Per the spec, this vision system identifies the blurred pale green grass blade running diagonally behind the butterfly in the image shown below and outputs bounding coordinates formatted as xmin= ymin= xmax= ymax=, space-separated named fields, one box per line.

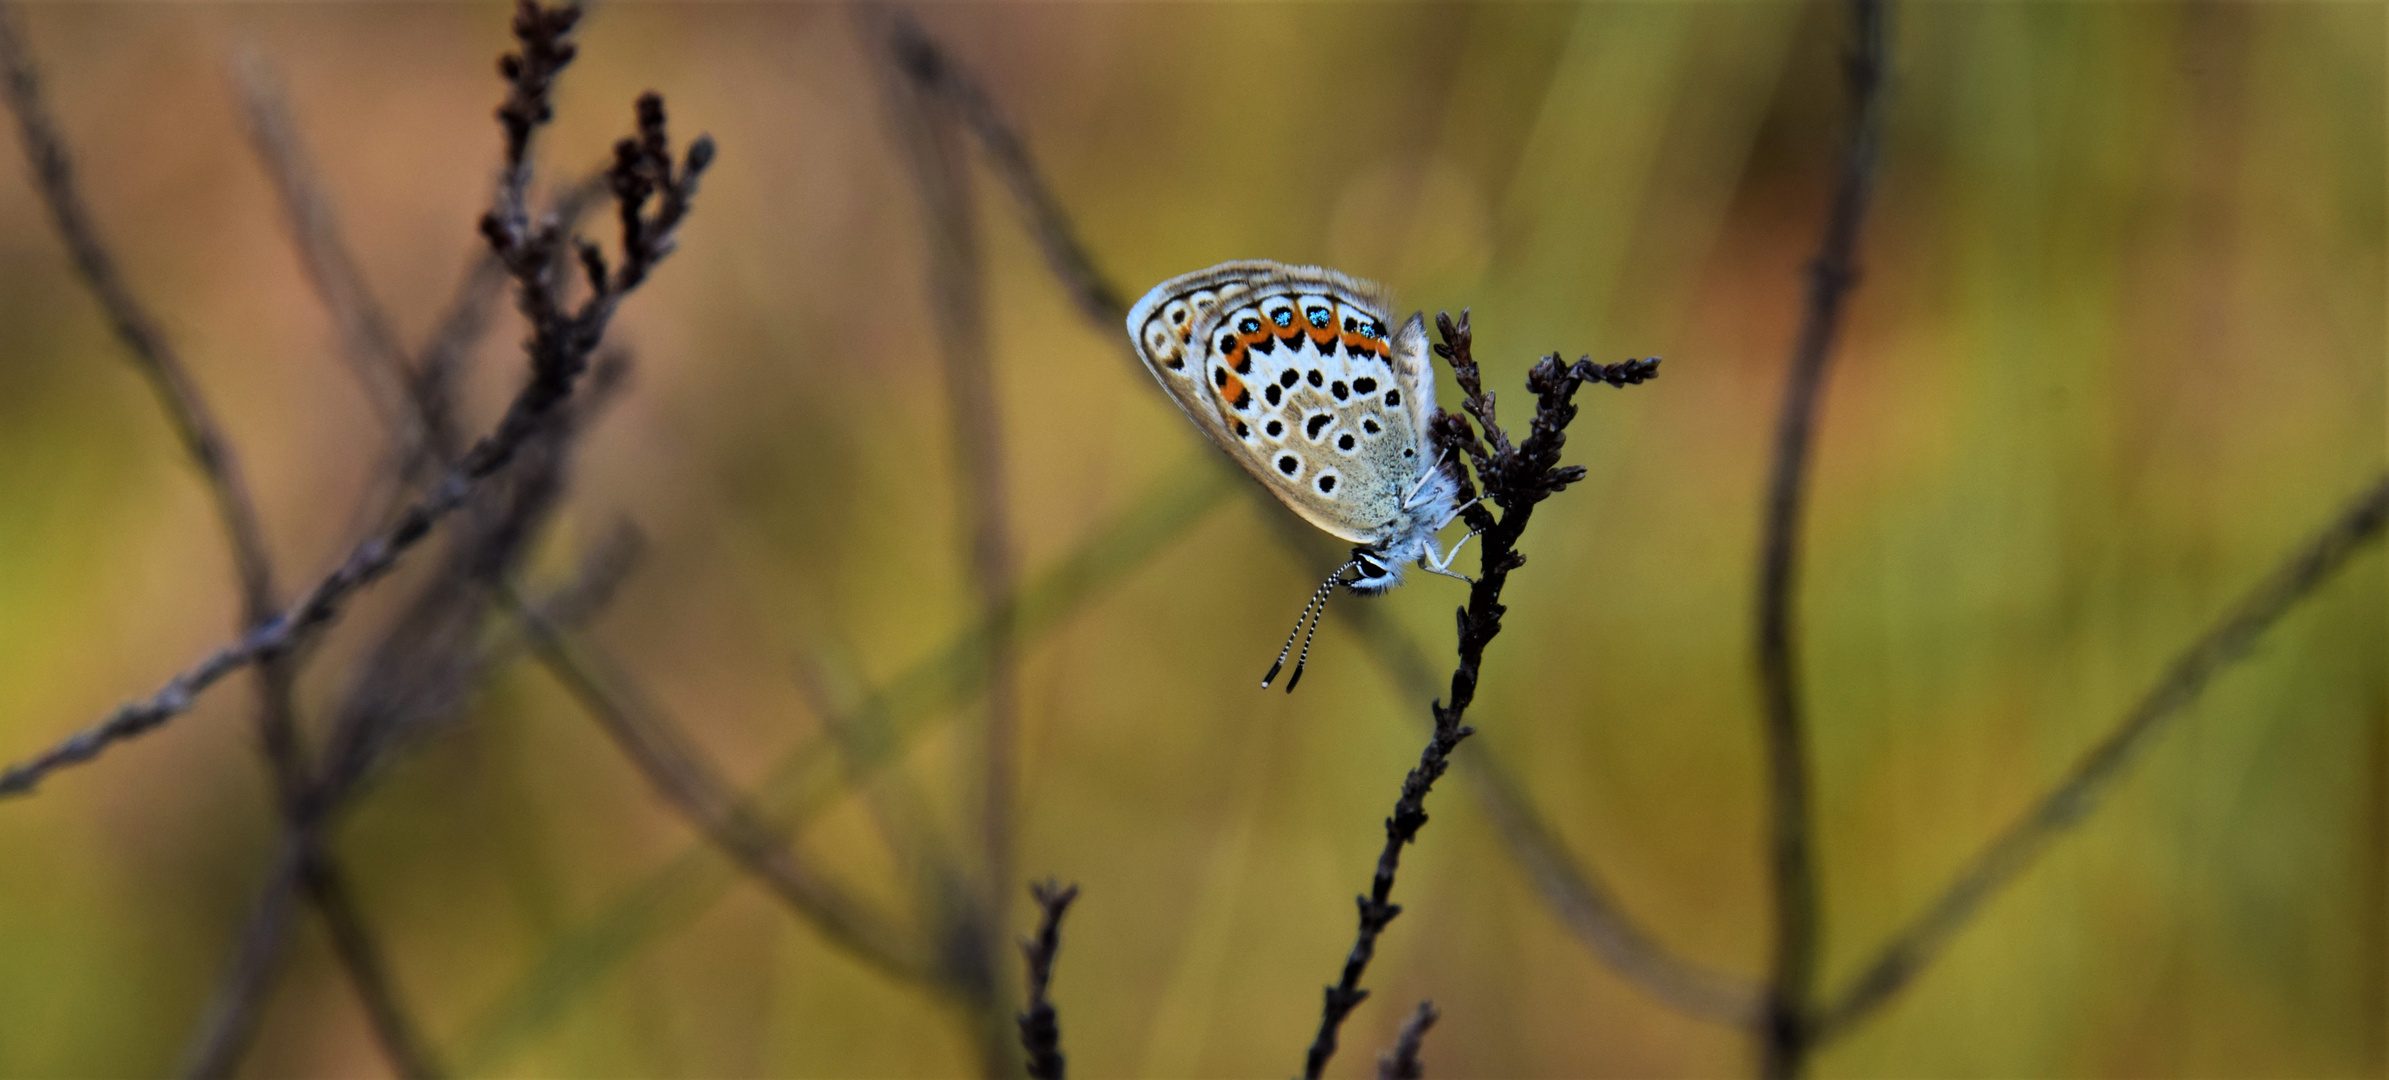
xmin=447 ymin=449 xmax=1238 ymax=1075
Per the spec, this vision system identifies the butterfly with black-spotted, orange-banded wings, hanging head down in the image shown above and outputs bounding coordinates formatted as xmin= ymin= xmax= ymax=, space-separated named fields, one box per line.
xmin=1128 ymin=260 xmax=1474 ymax=693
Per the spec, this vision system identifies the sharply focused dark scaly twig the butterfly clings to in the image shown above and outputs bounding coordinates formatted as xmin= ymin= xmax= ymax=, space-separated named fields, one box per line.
xmin=1302 ymin=311 xmax=1658 ymax=1080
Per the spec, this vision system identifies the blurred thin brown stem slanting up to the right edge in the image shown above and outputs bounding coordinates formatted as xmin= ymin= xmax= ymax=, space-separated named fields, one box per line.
xmin=1813 ymin=473 xmax=2389 ymax=1042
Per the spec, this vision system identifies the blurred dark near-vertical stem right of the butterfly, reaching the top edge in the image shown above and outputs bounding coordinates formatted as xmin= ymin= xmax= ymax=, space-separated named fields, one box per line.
xmin=1751 ymin=0 xmax=1885 ymax=1078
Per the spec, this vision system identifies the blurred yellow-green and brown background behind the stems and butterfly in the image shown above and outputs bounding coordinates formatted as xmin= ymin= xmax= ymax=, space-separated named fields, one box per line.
xmin=0 ymin=2 xmax=2389 ymax=1078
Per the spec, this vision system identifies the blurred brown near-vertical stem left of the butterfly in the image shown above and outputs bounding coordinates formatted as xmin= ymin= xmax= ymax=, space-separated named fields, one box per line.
xmin=858 ymin=7 xmax=1020 ymax=1060
